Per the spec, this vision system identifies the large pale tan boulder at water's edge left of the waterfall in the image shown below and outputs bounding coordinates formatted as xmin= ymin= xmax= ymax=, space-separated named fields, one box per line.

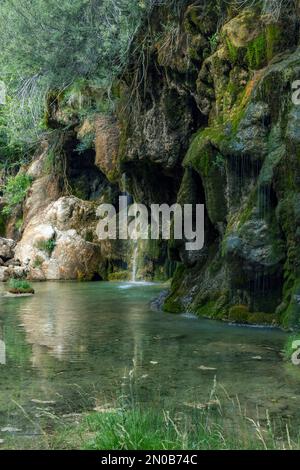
xmin=16 ymin=197 xmax=105 ymax=280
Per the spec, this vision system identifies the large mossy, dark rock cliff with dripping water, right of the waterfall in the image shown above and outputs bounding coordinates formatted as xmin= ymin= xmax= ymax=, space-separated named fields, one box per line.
xmin=116 ymin=1 xmax=300 ymax=326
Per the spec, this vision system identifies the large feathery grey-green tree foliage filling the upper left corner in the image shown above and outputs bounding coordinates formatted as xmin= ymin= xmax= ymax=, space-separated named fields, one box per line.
xmin=0 ymin=0 xmax=156 ymax=152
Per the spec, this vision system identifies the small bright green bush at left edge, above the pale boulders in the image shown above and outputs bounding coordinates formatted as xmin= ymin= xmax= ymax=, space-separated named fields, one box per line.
xmin=2 ymin=174 xmax=32 ymax=215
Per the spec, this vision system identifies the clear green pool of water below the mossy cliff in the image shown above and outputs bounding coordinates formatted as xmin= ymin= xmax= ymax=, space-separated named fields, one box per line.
xmin=0 ymin=282 xmax=300 ymax=446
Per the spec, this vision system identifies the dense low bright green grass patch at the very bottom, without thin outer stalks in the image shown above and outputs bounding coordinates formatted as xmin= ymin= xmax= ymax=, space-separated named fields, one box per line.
xmin=45 ymin=408 xmax=299 ymax=450
